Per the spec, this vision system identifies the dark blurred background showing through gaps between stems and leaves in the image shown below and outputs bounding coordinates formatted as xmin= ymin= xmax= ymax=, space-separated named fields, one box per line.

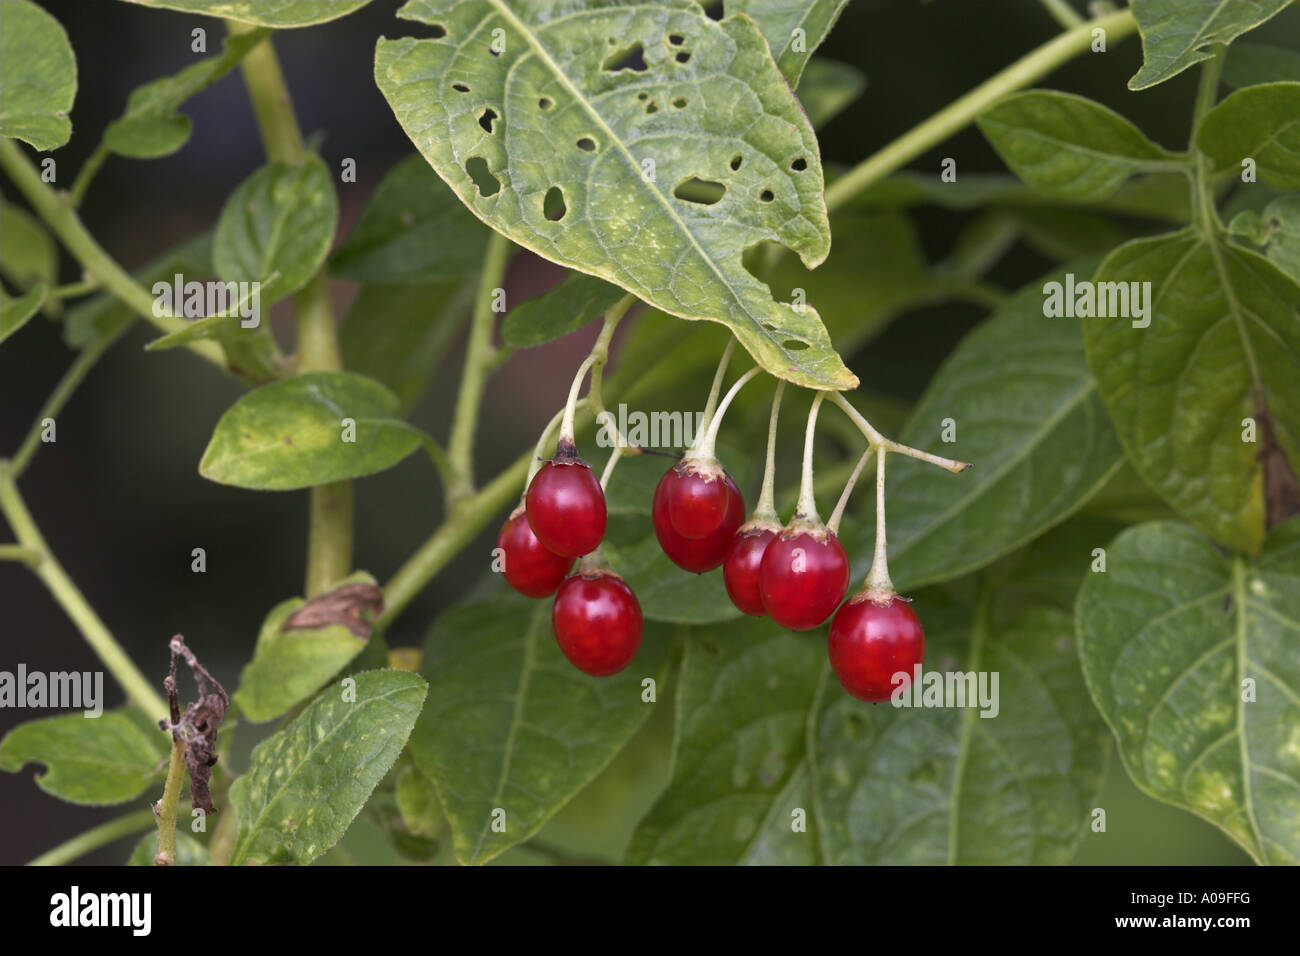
xmin=0 ymin=0 xmax=1300 ymax=864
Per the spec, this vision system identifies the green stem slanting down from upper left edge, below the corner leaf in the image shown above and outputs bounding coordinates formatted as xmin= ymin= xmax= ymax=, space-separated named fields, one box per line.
xmin=0 ymin=138 xmax=229 ymax=372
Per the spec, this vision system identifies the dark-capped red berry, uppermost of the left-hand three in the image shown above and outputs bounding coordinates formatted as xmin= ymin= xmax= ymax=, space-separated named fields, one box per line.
xmin=527 ymin=454 xmax=606 ymax=558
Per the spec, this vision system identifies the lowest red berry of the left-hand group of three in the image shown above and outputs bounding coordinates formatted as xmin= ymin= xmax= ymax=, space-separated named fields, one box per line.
xmin=551 ymin=571 xmax=641 ymax=678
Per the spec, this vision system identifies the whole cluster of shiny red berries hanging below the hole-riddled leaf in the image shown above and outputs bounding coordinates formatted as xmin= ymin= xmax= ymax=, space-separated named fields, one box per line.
xmin=497 ymin=442 xmax=926 ymax=701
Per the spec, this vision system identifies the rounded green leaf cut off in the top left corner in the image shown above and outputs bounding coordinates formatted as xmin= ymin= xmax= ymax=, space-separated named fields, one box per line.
xmin=0 ymin=0 xmax=77 ymax=152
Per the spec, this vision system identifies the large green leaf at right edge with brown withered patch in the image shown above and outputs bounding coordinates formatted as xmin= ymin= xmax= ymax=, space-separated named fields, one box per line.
xmin=1084 ymin=229 xmax=1300 ymax=553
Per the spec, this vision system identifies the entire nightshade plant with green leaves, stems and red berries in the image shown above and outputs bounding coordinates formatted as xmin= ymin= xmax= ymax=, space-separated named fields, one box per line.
xmin=0 ymin=0 xmax=1300 ymax=865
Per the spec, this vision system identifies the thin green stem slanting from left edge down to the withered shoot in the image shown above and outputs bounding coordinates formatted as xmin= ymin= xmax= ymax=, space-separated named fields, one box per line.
xmin=0 ymin=460 xmax=168 ymax=721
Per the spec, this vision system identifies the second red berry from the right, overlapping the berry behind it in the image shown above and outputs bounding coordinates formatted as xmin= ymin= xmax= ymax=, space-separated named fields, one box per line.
xmin=758 ymin=522 xmax=849 ymax=631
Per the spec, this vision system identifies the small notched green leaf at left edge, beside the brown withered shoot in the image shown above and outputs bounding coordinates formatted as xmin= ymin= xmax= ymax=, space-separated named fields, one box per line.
xmin=0 ymin=709 xmax=169 ymax=806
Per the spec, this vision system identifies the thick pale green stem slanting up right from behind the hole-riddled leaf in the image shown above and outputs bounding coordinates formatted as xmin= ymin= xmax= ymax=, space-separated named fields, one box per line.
xmin=826 ymin=10 xmax=1138 ymax=209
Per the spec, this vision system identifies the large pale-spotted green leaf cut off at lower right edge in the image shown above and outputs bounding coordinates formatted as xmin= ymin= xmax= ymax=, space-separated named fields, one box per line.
xmin=1076 ymin=520 xmax=1300 ymax=864
